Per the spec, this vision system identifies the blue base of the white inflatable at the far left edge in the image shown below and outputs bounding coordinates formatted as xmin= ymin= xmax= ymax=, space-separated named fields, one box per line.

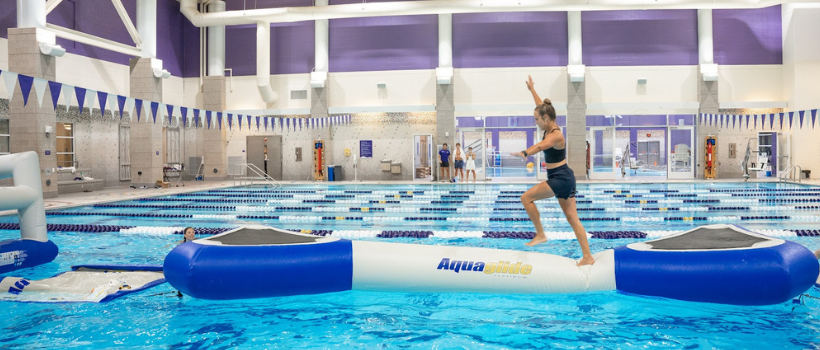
xmin=0 ymin=239 xmax=59 ymax=273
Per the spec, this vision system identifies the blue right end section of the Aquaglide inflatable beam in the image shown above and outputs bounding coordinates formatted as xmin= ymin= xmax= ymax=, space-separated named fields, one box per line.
xmin=615 ymin=241 xmax=820 ymax=305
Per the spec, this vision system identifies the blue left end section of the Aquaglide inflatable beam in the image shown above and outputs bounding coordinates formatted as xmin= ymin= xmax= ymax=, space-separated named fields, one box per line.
xmin=163 ymin=240 xmax=353 ymax=300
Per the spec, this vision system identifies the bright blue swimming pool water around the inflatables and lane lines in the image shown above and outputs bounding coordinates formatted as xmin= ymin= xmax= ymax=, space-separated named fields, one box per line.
xmin=0 ymin=183 xmax=820 ymax=349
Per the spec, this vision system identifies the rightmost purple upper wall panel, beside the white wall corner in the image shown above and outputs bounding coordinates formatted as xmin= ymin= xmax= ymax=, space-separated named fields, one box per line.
xmin=712 ymin=6 xmax=783 ymax=64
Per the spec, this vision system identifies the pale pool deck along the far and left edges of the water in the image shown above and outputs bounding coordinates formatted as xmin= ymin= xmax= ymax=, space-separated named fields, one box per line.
xmin=0 ymin=177 xmax=820 ymax=216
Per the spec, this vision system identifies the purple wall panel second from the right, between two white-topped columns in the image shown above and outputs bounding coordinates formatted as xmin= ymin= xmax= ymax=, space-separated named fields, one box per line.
xmin=581 ymin=10 xmax=698 ymax=66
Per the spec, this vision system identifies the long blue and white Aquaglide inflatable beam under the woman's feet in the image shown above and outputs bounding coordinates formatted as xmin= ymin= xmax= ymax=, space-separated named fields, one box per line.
xmin=163 ymin=225 xmax=820 ymax=305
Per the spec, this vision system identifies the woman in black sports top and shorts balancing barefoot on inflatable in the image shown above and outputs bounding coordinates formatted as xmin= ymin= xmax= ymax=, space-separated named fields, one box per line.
xmin=512 ymin=76 xmax=595 ymax=266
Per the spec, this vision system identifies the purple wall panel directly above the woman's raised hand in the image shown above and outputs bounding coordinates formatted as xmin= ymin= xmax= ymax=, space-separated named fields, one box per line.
xmin=453 ymin=12 xmax=568 ymax=68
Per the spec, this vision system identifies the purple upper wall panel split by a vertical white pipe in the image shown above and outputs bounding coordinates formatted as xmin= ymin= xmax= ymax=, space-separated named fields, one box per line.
xmin=225 ymin=21 xmax=315 ymax=75
